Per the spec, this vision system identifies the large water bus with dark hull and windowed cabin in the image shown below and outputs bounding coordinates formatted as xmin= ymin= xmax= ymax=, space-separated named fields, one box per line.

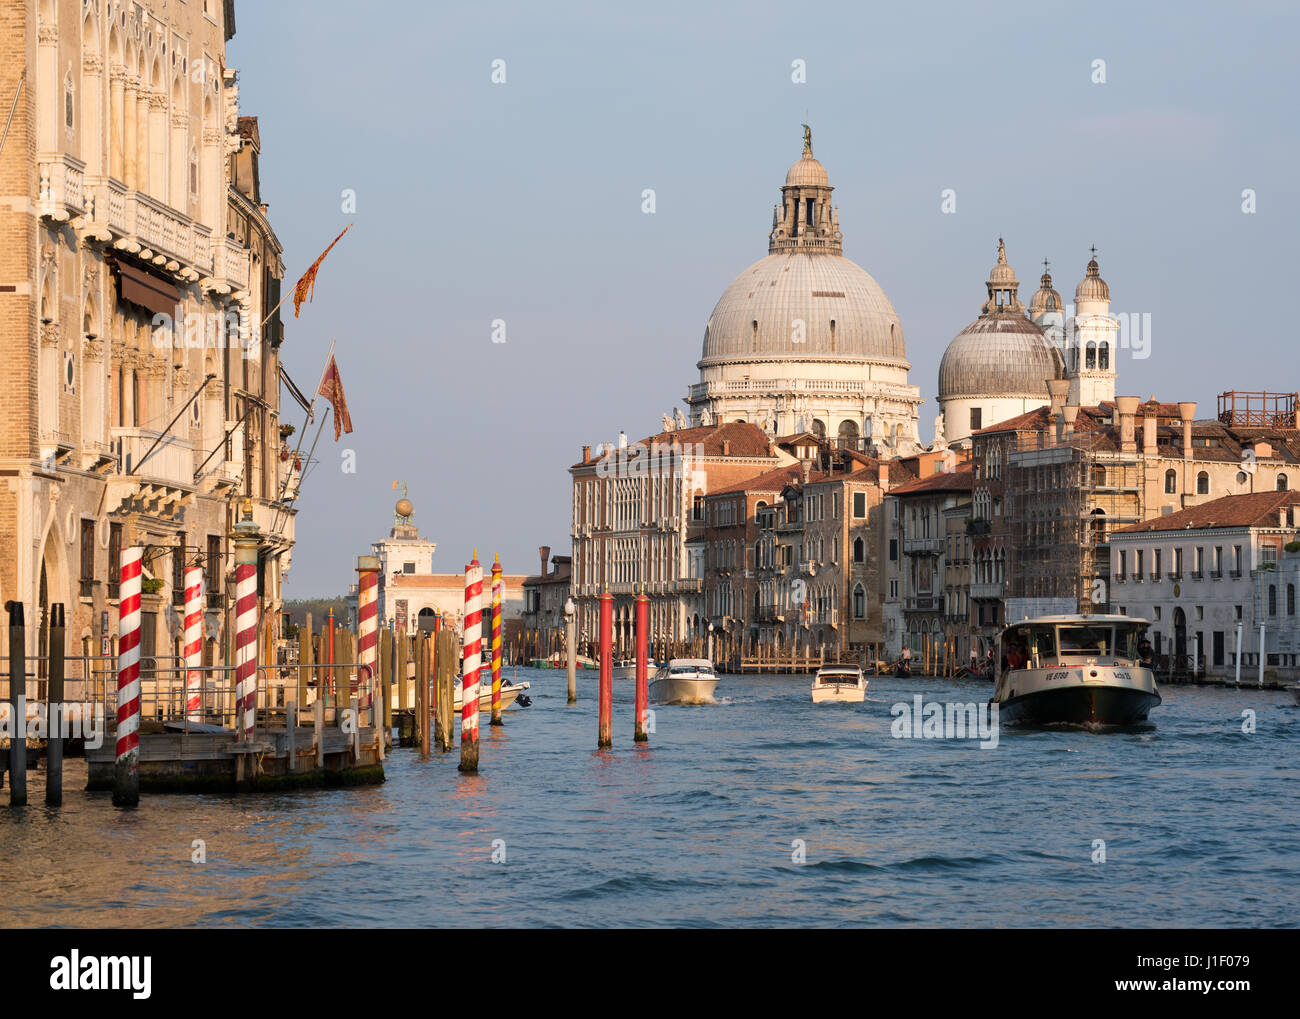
xmin=993 ymin=616 xmax=1161 ymax=725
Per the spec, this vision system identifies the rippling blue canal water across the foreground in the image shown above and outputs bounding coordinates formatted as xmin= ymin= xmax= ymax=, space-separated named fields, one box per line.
xmin=0 ymin=669 xmax=1300 ymax=927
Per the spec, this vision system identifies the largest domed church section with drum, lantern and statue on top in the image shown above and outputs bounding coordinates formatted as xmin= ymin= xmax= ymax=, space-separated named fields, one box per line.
xmin=686 ymin=129 xmax=920 ymax=456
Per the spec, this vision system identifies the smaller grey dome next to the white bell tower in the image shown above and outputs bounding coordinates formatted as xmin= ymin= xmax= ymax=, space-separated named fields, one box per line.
xmin=939 ymin=315 xmax=1065 ymax=402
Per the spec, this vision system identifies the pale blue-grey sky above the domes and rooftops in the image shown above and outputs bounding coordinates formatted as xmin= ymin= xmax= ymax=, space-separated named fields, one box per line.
xmin=228 ymin=0 xmax=1300 ymax=598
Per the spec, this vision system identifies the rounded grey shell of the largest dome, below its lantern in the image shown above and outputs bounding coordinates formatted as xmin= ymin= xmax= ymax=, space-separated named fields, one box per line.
xmin=699 ymin=248 xmax=907 ymax=368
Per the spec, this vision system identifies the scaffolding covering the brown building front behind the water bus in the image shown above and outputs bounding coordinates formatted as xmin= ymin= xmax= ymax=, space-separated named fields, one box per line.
xmin=1004 ymin=432 xmax=1144 ymax=615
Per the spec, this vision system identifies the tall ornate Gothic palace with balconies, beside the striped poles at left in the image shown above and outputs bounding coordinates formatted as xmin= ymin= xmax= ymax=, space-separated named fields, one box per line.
xmin=0 ymin=0 xmax=298 ymax=668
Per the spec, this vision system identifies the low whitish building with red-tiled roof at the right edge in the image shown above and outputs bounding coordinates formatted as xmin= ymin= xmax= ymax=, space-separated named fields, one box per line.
xmin=1109 ymin=490 xmax=1300 ymax=682
